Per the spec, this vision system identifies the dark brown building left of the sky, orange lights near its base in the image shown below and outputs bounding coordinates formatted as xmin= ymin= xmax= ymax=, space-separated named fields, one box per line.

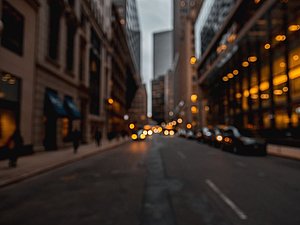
xmin=106 ymin=4 xmax=141 ymax=139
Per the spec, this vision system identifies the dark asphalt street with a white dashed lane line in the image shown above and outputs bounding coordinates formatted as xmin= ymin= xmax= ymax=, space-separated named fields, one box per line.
xmin=0 ymin=136 xmax=300 ymax=225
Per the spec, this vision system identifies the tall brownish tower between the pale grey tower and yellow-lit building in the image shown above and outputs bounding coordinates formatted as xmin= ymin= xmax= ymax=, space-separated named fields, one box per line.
xmin=173 ymin=0 xmax=202 ymax=125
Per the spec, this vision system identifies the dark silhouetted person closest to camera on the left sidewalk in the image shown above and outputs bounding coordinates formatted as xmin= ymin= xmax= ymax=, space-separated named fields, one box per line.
xmin=6 ymin=128 xmax=23 ymax=167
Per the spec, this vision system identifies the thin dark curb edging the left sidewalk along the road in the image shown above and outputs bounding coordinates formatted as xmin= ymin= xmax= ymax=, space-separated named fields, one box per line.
xmin=0 ymin=140 xmax=129 ymax=188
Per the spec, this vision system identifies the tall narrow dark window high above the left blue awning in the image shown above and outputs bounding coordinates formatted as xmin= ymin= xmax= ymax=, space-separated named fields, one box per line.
xmin=48 ymin=1 xmax=61 ymax=60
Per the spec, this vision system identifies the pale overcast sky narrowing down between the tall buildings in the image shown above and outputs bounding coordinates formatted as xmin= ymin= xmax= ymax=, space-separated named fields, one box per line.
xmin=136 ymin=0 xmax=173 ymax=112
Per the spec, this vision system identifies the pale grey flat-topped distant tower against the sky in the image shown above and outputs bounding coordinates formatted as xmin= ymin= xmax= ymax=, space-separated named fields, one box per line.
xmin=153 ymin=31 xmax=173 ymax=79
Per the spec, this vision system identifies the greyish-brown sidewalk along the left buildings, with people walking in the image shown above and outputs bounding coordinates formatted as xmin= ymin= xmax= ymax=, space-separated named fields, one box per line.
xmin=0 ymin=138 xmax=129 ymax=188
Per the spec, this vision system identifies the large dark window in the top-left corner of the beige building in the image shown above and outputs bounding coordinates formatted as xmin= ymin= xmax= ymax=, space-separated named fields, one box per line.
xmin=1 ymin=1 xmax=24 ymax=55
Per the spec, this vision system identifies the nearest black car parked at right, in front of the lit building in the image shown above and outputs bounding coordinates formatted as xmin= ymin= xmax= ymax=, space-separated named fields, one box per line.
xmin=221 ymin=126 xmax=267 ymax=155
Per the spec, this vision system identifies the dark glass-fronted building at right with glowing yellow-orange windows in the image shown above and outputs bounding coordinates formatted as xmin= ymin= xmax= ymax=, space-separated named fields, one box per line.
xmin=197 ymin=0 xmax=300 ymax=139
